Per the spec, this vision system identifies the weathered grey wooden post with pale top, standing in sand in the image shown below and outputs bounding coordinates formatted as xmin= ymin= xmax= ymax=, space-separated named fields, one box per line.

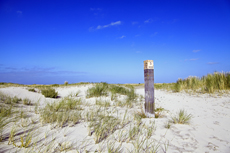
xmin=144 ymin=60 xmax=155 ymax=117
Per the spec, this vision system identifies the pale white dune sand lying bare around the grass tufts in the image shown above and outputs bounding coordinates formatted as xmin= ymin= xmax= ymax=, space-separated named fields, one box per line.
xmin=0 ymin=85 xmax=230 ymax=153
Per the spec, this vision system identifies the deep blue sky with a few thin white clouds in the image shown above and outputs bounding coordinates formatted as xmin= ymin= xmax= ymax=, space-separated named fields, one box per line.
xmin=0 ymin=0 xmax=230 ymax=84
